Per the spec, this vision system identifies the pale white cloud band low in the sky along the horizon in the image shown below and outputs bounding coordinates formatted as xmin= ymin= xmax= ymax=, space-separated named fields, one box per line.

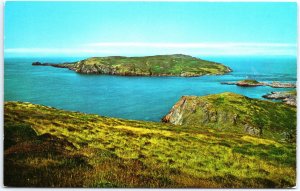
xmin=4 ymin=42 xmax=297 ymax=55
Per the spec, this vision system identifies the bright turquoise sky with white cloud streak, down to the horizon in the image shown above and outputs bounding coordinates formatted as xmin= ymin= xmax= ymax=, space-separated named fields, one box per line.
xmin=4 ymin=1 xmax=297 ymax=57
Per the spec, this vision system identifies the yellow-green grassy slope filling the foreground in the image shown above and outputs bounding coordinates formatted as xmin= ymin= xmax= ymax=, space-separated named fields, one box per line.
xmin=4 ymin=102 xmax=296 ymax=188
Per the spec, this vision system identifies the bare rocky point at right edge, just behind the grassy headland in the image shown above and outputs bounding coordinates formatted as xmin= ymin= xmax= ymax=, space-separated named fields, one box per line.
xmin=262 ymin=90 xmax=297 ymax=106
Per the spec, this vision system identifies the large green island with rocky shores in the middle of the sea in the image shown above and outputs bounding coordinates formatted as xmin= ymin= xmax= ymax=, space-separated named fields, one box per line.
xmin=32 ymin=54 xmax=232 ymax=77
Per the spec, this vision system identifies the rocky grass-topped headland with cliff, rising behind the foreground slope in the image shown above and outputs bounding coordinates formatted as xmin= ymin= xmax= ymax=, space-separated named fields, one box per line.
xmin=162 ymin=93 xmax=296 ymax=141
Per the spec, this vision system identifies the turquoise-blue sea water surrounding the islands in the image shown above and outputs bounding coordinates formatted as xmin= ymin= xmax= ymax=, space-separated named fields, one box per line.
xmin=4 ymin=57 xmax=297 ymax=121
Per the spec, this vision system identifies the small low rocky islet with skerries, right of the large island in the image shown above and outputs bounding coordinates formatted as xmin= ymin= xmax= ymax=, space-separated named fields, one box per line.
xmin=221 ymin=79 xmax=296 ymax=88
